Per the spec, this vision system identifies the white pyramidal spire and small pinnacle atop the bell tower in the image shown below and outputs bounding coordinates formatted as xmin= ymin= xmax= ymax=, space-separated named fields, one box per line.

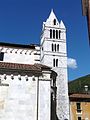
xmin=44 ymin=9 xmax=65 ymax=28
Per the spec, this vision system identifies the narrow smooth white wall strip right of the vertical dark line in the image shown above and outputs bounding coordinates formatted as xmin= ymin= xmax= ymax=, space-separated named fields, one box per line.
xmin=38 ymin=81 xmax=51 ymax=120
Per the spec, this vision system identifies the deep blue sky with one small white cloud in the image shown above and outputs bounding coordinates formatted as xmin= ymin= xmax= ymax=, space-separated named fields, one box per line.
xmin=0 ymin=0 xmax=90 ymax=80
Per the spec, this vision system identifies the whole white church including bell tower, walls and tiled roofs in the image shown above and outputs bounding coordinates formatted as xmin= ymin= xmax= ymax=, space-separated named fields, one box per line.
xmin=0 ymin=10 xmax=70 ymax=120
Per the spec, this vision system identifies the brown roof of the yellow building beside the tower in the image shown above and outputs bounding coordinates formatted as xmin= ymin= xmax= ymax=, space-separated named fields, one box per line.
xmin=69 ymin=93 xmax=90 ymax=101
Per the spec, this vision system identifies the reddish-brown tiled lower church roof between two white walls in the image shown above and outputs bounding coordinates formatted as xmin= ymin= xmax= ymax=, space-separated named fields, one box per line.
xmin=0 ymin=62 xmax=50 ymax=72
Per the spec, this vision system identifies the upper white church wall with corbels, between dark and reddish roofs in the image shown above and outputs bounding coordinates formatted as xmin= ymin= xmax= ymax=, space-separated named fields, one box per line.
xmin=0 ymin=47 xmax=40 ymax=64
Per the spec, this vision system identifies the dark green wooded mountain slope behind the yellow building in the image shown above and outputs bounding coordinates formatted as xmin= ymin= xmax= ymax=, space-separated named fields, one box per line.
xmin=68 ymin=74 xmax=90 ymax=93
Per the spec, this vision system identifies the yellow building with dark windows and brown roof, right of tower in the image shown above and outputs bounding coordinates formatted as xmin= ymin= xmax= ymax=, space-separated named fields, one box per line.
xmin=70 ymin=93 xmax=90 ymax=120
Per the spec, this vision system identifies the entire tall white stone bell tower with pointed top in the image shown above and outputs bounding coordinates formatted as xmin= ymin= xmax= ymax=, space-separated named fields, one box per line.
xmin=41 ymin=10 xmax=69 ymax=120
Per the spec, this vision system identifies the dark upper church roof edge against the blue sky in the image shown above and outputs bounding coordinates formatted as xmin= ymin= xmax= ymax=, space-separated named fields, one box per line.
xmin=0 ymin=42 xmax=39 ymax=49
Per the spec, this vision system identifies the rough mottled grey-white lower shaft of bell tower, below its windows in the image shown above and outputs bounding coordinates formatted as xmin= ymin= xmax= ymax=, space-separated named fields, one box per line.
xmin=53 ymin=68 xmax=69 ymax=120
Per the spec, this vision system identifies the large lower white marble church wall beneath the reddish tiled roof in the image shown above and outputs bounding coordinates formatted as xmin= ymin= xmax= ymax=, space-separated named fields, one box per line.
xmin=0 ymin=71 xmax=51 ymax=120
